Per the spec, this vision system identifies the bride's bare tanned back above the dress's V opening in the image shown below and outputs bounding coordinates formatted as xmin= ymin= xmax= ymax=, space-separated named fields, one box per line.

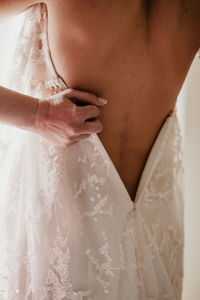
xmin=0 ymin=0 xmax=200 ymax=200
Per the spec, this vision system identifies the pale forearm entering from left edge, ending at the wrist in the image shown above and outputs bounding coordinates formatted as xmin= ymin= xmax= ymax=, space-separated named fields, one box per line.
xmin=0 ymin=86 xmax=38 ymax=130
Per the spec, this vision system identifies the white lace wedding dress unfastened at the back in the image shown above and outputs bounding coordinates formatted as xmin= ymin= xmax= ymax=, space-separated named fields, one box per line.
xmin=0 ymin=4 xmax=184 ymax=300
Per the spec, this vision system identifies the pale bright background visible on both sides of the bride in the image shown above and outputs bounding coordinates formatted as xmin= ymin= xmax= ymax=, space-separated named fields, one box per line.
xmin=0 ymin=14 xmax=200 ymax=300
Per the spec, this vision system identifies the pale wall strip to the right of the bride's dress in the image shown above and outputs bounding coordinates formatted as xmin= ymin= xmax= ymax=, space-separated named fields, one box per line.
xmin=179 ymin=57 xmax=200 ymax=300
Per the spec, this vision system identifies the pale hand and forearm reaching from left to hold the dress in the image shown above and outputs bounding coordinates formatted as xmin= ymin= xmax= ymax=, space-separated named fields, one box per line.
xmin=0 ymin=87 xmax=105 ymax=147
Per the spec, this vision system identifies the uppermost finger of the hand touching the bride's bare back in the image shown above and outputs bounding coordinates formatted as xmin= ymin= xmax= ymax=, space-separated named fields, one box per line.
xmin=63 ymin=88 xmax=107 ymax=106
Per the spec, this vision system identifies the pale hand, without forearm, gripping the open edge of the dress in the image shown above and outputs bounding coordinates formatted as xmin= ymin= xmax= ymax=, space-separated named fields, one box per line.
xmin=34 ymin=88 xmax=106 ymax=146
